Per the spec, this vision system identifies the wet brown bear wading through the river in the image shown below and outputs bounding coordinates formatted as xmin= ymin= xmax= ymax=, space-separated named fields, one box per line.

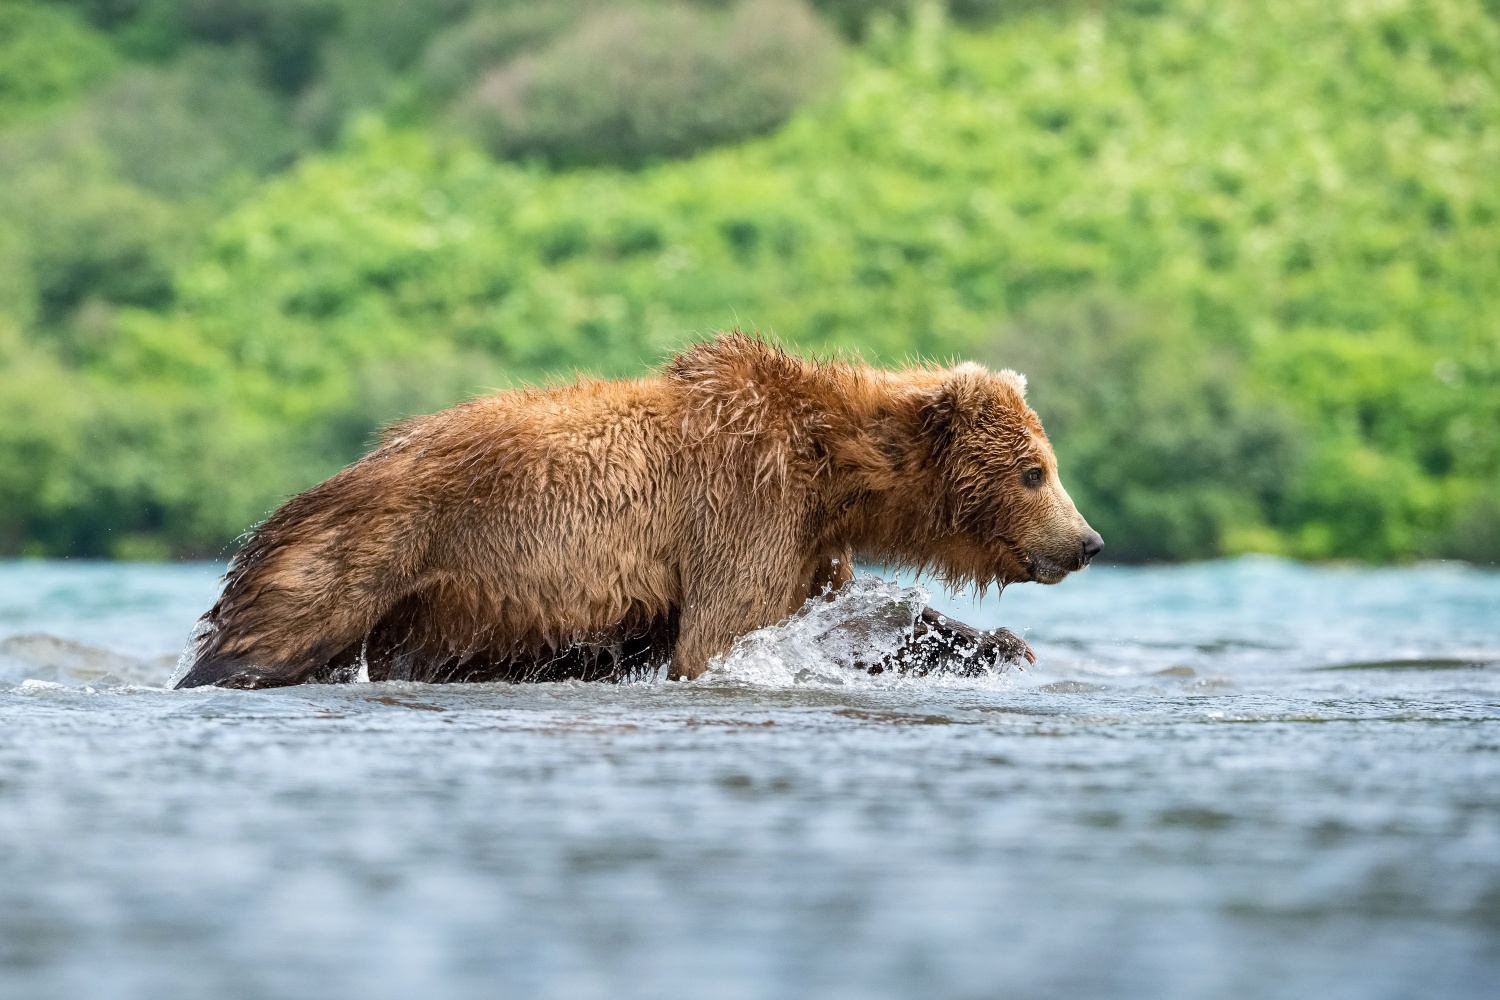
xmin=179 ymin=331 xmax=1104 ymax=688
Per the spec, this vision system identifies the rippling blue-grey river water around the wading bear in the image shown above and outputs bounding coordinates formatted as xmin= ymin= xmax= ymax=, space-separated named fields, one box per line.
xmin=0 ymin=559 xmax=1500 ymax=1000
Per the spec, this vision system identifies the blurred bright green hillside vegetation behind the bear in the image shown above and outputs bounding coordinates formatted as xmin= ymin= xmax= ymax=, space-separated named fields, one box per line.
xmin=0 ymin=0 xmax=1500 ymax=562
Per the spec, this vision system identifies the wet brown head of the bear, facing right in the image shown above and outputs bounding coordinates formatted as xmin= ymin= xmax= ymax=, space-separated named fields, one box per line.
xmin=917 ymin=363 xmax=1104 ymax=585
